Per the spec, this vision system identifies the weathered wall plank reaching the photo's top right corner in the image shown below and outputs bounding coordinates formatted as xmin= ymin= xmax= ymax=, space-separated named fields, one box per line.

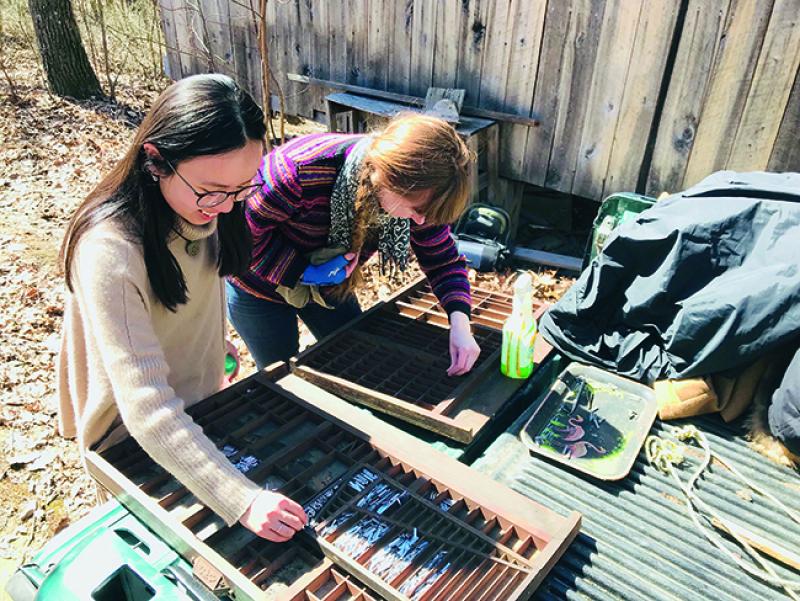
xmin=727 ymin=0 xmax=800 ymax=170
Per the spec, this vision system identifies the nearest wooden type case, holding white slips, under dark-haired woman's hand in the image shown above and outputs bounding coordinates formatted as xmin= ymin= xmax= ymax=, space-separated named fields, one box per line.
xmin=87 ymin=366 xmax=580 ymax=601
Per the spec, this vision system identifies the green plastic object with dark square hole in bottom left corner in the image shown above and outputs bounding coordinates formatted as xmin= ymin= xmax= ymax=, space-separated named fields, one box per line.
xmin=9 ymin=501 xmax=227 ymax=601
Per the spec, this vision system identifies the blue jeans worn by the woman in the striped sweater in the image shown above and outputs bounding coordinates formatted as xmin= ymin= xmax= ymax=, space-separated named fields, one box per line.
xmin=225 ymin=282 xmax=361 ymax=369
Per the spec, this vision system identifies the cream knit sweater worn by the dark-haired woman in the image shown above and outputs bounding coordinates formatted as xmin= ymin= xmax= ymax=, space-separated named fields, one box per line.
xmin=57 ymin=218 xmax=260 ymax=525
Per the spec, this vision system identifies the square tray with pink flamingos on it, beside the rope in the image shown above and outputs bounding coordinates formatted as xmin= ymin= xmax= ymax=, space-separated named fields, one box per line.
xmin=520 ymin=363 xmax=657 ymax=480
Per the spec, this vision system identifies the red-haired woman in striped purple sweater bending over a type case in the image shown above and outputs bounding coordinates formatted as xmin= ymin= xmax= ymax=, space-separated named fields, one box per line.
xmin=227 ymin=113 xmax=480 ymax=376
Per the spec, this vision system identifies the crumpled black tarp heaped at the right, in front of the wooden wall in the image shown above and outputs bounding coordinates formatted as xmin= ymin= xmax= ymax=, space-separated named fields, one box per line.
xmin=539 ymin=171 xmax=800 ymax=382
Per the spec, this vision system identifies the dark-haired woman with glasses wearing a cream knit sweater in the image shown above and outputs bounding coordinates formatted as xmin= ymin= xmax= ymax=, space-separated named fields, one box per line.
xmin=57 ymin=75 xmax=307 ymax=542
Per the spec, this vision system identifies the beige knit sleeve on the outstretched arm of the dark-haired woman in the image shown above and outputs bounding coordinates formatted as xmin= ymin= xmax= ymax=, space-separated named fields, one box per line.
xmin=74 ymin=232 xmax=261 ymax=525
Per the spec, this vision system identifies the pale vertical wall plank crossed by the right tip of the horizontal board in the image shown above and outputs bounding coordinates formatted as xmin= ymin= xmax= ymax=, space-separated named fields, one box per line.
xmin=500 ymin=0 xmax=550 ymax=181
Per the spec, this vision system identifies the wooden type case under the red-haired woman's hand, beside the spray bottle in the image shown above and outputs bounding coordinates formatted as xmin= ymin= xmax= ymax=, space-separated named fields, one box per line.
xmin=291 ymin=280 xmax=551 ymax=443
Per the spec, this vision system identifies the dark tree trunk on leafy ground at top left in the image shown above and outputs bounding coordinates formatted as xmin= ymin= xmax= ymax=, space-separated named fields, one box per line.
xmin=28 ymin=0 xmax=102 ymax=98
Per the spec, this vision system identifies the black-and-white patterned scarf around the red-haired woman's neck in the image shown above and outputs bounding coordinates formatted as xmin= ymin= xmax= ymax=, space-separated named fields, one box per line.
xmin=328 ymin=136 xmax=411 ymax=274
